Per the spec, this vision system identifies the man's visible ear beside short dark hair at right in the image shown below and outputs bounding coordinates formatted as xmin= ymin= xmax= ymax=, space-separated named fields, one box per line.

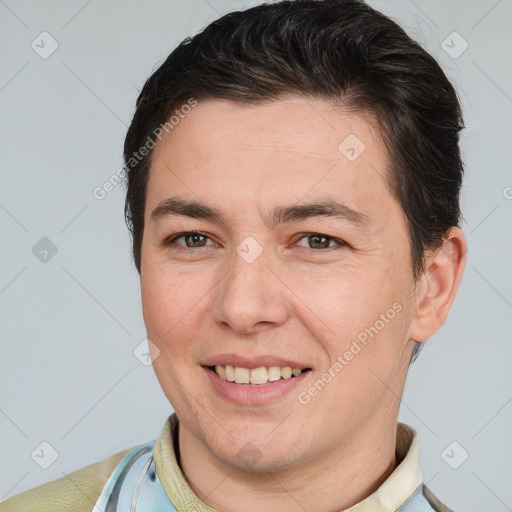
xmin=409 ymin=227 xmax=467 ymax=342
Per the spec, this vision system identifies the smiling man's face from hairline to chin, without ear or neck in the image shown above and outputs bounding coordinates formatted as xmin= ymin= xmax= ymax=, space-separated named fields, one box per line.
xmin=141 ymin=97 xmax=415 ymax=471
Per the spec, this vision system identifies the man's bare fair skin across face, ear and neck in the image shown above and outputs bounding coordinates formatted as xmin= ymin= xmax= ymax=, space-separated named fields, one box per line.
xmin=141 ymin=97 xmax=465 ymax=512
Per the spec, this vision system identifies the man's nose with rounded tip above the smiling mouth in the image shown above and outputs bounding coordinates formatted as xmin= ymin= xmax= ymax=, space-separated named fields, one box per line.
xmin=212 ymin=244 xmax=290 ymax=335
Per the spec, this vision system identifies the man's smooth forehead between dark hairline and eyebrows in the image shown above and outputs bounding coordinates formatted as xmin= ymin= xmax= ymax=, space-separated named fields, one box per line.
xmin=146 ymin=97 xmax=391 ymax=224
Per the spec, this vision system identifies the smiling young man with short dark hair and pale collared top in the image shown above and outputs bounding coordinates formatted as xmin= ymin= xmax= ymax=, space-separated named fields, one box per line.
xmin=0 ymin=0 xmax=465 ymax=512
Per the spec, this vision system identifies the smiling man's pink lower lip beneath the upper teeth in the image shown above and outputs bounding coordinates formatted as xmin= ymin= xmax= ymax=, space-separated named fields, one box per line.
xmin=203 ymin=366 xmax=311 ymax=405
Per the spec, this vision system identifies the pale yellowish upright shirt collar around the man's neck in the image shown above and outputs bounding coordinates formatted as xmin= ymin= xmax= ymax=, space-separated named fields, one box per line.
xmin=154 ymin=413 xmax=422 ymax=512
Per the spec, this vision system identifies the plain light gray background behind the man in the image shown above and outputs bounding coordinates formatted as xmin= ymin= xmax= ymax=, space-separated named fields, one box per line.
xmin=0 ymin=0 xmax=512 ymax=512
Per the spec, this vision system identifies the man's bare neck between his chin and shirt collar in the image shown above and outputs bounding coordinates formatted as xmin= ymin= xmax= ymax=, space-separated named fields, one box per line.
xmin=179 ymin=418 xmax=397 ymax=512
